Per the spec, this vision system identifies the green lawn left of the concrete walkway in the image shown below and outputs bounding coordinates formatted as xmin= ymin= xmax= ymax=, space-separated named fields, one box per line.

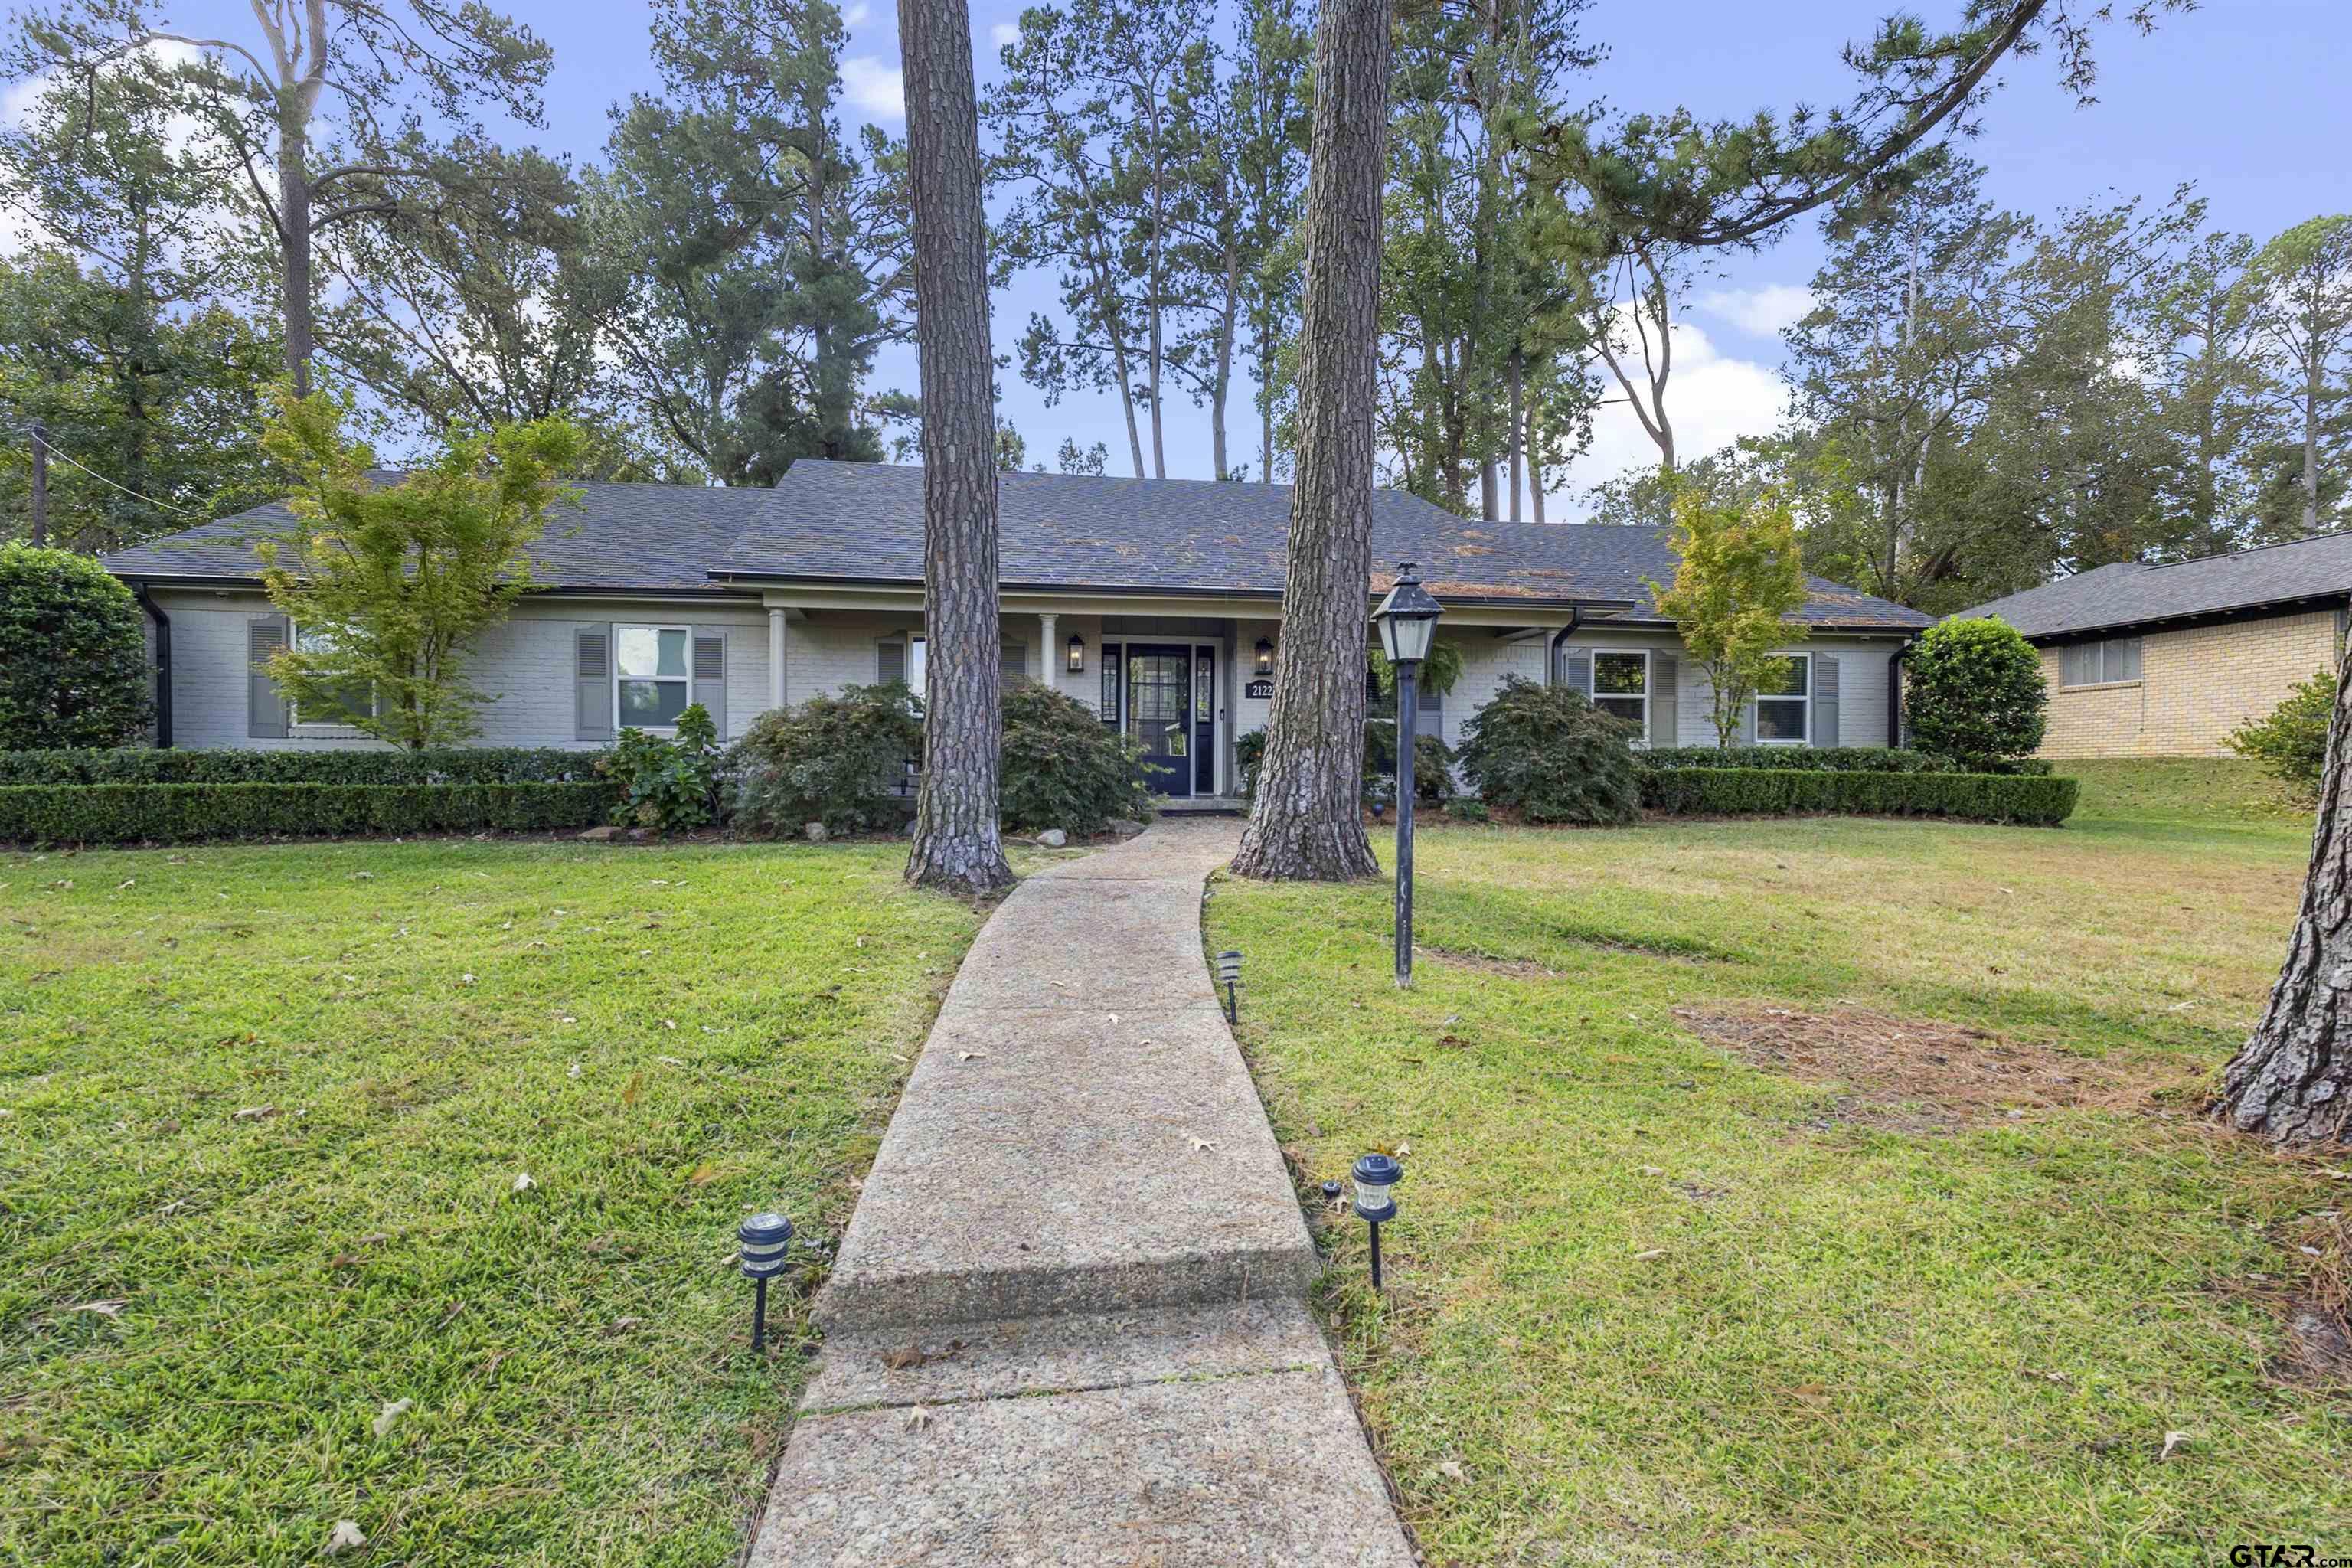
xmin=0 ymin=841 xmax=1025 ymax=1568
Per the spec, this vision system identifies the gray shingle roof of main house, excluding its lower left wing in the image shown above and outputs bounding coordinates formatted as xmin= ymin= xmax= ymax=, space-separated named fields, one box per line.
xmin=717 ymin=461 xmax=1929 ymax=628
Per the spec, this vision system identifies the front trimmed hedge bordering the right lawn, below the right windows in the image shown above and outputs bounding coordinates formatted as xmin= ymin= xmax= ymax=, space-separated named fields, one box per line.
xmin=1642 ymin=766 xmax=2082 ymax=828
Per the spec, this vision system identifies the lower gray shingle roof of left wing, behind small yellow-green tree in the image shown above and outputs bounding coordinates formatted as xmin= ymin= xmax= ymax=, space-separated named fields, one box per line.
xmin=103 ymin=482 xmax=769 ymax=593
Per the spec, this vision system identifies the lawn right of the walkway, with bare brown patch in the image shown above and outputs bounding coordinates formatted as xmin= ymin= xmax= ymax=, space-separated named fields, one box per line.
xmin=1207 ymin=764 xmax=2352 ymax=1566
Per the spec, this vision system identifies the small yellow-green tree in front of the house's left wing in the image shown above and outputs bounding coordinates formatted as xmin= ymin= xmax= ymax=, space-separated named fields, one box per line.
xmin=254 ymin=386 xmax=586 ymax=750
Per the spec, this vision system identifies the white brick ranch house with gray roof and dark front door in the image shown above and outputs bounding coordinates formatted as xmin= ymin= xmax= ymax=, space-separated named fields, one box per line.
xmin=106 ymin=459 xmax=1926 ymax=797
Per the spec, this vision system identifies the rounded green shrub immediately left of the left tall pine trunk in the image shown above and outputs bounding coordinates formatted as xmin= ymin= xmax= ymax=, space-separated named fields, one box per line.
xmin=729 ymin=681 xmax=922 ymax=832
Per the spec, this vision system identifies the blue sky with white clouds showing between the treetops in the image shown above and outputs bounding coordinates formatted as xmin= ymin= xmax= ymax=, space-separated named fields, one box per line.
xmin=37 ymin=0 xmax=2352 ymax=520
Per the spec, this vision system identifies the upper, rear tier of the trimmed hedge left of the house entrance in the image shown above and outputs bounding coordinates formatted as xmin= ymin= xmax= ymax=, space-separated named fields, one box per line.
xmin=0 ymin=745 xmax=602 ymax=786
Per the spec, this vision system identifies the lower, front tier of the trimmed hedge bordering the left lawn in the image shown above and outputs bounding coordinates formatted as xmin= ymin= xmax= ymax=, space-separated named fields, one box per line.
xmin=0 ymin=782 xmax=621 ymax=844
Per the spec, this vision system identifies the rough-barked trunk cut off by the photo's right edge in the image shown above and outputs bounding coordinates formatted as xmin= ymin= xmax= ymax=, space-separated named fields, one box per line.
xmin=2213 ymin=656 xmax=2352 ymax=1142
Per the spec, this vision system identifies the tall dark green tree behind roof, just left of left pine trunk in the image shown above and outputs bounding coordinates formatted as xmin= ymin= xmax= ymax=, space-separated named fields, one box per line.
xmin=581 ymin=0 xmax=910 ymax=485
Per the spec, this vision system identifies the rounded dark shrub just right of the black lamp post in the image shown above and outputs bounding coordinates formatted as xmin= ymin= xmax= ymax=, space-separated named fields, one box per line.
xmin=1461 ymin=675 xmax=1642 ymax=828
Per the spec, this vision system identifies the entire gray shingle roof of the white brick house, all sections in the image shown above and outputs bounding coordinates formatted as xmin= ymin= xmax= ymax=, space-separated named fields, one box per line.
xmin=106 ymin=459 xmax=1929 ymax=630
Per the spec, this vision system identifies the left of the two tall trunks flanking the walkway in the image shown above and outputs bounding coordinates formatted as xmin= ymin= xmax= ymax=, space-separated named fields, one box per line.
xmin=899 ymin=0 xmax=1014 ymax=893
